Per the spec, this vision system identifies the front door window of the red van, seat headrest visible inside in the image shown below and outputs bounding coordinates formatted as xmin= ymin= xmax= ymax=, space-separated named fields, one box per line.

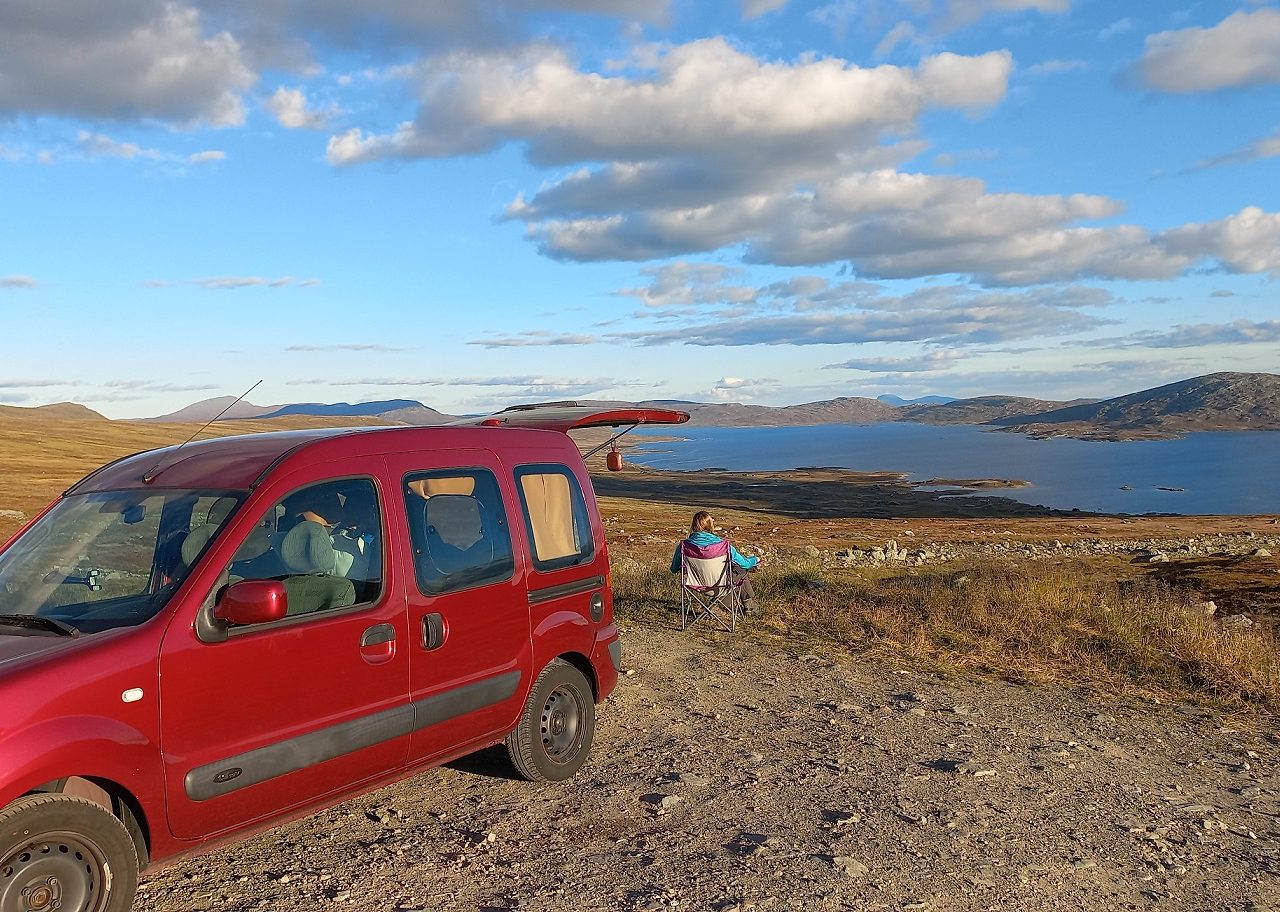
xmin=230 ymin=478 xmax=383 ymax=616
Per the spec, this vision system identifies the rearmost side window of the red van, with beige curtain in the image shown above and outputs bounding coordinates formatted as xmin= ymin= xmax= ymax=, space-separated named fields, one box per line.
xmin=516 ymin=465 xmax=595 ymax=570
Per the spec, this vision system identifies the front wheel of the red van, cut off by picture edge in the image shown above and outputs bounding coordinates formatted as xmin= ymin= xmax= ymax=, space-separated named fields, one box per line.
xmin=0 ymin=794 xmax=138 ymax=912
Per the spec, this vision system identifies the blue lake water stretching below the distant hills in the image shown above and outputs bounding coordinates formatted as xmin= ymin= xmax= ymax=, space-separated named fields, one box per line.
xmin=627 ymin=423 xmax=1280 ymax=514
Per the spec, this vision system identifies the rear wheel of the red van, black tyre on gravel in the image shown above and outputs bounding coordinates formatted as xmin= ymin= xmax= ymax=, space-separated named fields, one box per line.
xmin=507 ymin=658 xmax=595 ymax=783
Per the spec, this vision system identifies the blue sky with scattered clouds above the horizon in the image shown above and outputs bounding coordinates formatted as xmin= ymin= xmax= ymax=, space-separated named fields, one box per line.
xmin=0 ymin=0 xmax=1280 ymax=418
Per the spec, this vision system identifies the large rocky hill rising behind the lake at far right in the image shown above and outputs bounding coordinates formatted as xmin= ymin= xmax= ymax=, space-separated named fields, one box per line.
xmin=1014 ymin=371 xmax=1280 ymax=437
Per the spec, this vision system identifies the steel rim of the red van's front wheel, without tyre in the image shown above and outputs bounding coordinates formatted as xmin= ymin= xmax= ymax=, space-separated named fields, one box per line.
xmin=0 ymin=831 xmax=111 ymax=912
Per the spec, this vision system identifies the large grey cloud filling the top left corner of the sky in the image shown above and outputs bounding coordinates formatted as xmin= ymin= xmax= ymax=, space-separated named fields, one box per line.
xmin=0 ymin=0 xmax=256 ymax=127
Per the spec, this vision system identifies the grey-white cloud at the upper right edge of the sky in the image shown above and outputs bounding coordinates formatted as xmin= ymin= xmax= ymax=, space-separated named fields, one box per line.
xmin=1139 ymin=8 xmax=1280 ymax=92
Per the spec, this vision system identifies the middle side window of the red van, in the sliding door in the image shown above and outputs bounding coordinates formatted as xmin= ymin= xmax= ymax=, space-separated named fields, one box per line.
xmin=404 ymin=469 xmax=516 ymax=596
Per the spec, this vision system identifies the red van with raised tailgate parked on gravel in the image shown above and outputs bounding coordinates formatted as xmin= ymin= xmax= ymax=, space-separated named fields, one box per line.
xmin=0 ymin=403 xmax=689 ymax=912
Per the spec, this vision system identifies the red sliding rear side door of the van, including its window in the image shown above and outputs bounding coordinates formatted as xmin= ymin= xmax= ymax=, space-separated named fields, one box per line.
xmin=390 ymin=448 xmax=531 ymax=762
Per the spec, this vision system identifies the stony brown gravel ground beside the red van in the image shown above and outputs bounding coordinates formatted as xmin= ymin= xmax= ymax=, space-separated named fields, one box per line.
xmin=134 ymin=625 xmax=1280 ymax=912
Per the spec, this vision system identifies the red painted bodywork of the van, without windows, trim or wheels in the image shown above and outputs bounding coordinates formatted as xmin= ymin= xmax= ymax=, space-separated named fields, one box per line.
xmin=0 ymin=406 xmax=687 ymax=863
